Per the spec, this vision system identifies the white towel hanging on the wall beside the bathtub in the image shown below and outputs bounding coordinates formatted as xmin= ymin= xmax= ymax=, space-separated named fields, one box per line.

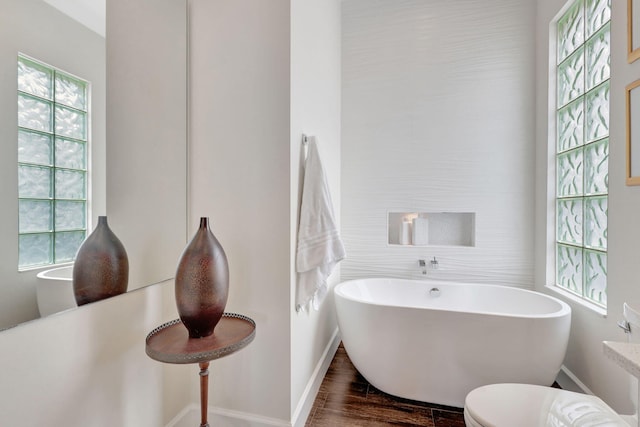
xmin=296 ymin=136 xmax=345 ymax=310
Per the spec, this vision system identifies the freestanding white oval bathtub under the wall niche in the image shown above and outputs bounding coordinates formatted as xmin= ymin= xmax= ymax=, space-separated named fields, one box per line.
xmin=334 ymin=279 xmax=571 ymax=407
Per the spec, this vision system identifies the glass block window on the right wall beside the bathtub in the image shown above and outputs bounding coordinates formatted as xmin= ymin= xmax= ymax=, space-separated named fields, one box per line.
xmin=554 ymin=0 xmax=611 ymax=307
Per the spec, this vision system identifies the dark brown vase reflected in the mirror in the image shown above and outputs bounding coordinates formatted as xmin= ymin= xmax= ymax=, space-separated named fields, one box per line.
xmin=73 ymin=216 xmax=129 ymax=305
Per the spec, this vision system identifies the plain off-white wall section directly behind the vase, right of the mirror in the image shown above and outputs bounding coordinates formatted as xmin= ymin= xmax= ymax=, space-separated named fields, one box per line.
xmin=189 ymin=0 xmax=291 ymax=421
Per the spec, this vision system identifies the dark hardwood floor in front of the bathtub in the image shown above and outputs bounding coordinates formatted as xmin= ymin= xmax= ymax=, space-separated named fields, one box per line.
xmin=306 ymin=344 xmax=464 ymax=427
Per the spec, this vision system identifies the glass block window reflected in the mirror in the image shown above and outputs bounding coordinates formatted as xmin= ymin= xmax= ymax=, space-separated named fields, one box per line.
xmin=17 ymin=55 xmax=89 ymax=269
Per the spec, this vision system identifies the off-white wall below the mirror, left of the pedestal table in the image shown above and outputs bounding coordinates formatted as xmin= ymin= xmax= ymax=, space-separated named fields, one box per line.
xmin=0 ymin=281 xmax=185 ymax=427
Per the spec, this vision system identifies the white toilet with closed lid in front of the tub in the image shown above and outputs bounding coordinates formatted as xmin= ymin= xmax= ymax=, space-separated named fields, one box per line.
xmin=464 ymin=384 xmax=633 ymax=427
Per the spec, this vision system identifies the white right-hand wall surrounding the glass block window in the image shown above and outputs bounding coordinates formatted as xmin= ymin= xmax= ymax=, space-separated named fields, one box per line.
xmin=535 ymin=0 xmax=640 ymax=413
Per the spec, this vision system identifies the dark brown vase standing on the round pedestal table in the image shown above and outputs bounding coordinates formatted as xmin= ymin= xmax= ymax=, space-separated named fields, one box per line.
xmin=175 ymin=217 xmax=229 ymax=338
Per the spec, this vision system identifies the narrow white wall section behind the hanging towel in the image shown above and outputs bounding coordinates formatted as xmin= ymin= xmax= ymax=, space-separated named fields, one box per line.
xmin=289 ymin=0 xmax=341 ymax=422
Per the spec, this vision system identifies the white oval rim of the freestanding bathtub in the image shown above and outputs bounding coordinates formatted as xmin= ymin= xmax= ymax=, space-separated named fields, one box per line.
xmin=333 ymin=277 xmax=571 ymax=319
